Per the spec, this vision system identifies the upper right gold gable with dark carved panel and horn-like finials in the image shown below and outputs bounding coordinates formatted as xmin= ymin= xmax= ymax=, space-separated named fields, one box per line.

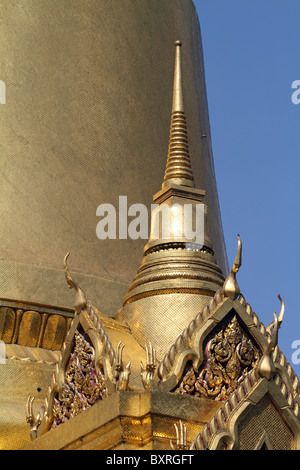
xmin=158 ymin=237 xmax=299 ymax=401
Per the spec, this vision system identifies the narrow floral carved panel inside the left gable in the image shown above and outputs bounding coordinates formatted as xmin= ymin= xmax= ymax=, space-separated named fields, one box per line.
xmin=52 ymin=331 xmax=107 ymax=427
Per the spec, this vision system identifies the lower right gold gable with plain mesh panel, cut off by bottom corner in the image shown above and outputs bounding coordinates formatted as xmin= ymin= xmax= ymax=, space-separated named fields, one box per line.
xmin=190 ymin=369 xmax=300 ymax=450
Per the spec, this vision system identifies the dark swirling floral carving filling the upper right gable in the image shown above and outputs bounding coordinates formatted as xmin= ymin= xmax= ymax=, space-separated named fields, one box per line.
xmin=176 ymin=316 xmax=260 ymax=401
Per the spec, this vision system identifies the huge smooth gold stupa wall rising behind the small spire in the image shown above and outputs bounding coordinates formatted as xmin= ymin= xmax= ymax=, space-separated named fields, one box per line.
xmin=0 ymin=0 xmax=226 ymax=315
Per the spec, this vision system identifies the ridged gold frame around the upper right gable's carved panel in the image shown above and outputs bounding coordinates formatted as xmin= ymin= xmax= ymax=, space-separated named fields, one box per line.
xmin=157 ymin=289 xmax=300 ymax=405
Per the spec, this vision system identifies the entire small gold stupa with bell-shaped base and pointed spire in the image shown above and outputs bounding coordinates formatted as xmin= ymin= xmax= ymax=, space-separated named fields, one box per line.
xmin=116 ymin=41 xmax=224 ymax=360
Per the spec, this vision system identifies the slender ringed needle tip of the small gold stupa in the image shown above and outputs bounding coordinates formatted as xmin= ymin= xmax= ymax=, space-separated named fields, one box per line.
xmin=162 ymin=41 xmax=194 ymax=188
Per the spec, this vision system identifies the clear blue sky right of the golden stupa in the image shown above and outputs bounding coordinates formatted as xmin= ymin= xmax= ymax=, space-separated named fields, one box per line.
xmin=194 ymin=0 xmax=300 ymax=375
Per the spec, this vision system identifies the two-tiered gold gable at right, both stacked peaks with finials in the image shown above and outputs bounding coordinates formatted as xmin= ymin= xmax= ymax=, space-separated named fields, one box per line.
xmin=154 ymin=240 xmax=300 ymax=450
